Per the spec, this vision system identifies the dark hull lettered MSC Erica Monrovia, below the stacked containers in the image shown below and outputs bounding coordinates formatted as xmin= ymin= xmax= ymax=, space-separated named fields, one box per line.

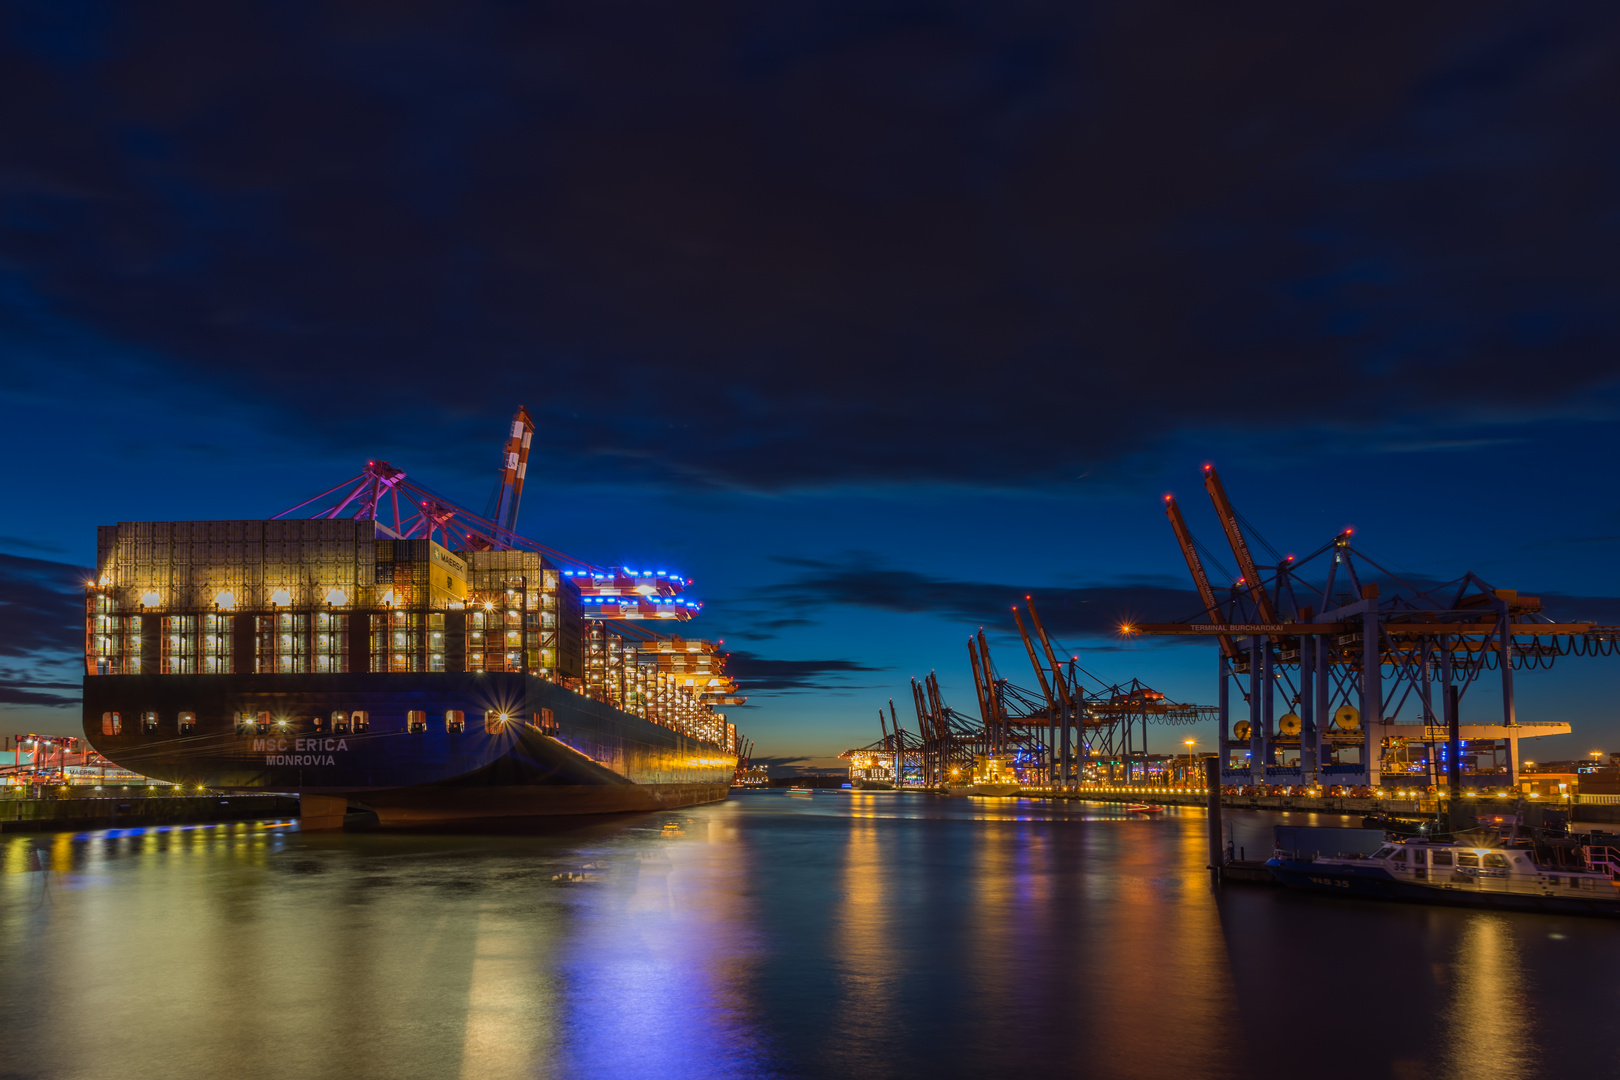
xmin=84 ymin=672 xmax=735 ymax=824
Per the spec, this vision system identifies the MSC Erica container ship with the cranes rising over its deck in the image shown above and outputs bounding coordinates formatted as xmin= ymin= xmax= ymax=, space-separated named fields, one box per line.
xmin=84 ymin=410 xmax=747 ymax=829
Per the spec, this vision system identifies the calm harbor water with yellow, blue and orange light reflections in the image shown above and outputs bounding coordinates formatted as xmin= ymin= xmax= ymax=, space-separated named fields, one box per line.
xmin=0 ymin=790 xmax=1620 ymax=1080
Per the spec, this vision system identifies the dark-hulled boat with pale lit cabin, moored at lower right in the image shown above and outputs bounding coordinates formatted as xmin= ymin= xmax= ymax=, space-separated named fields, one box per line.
xmin=1265 ymin=818 xmax=1620 ymax=918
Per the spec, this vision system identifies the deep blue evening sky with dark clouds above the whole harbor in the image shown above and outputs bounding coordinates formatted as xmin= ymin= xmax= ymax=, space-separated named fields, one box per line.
xmin=0 ymin=3 xmax=1620 ymax=763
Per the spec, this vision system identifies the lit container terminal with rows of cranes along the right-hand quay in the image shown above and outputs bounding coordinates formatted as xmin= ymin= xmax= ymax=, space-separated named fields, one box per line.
xmin=842 ymin=466 xmax=1620 ymax=819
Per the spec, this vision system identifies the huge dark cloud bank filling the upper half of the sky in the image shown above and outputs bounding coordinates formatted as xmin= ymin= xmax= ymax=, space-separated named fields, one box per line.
xmin=0 ymin=0 xmax=1620 ymax=488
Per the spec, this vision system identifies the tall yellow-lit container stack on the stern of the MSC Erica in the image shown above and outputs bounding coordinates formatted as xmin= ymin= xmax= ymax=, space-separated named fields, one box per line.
xmin=84 ymin=520 xmax=585 ymax=687
